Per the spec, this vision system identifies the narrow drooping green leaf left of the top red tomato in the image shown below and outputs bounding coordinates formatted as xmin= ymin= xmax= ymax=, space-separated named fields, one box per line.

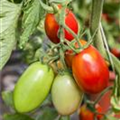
xmin=19 ymin=0 xmax=45 ymax=48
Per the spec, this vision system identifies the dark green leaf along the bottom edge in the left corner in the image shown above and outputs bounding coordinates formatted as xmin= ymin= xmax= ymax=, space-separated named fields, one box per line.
xmin=3 ymin=113 xmax=34 ymax=120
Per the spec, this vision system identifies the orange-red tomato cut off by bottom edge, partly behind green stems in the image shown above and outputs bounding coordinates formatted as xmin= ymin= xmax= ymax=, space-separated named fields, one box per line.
xmin=79 ymin=104 xmax=103 ymax=120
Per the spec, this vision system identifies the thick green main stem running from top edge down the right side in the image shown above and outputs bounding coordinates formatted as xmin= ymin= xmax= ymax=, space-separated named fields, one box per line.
xmin=91 ymin=0 xmax=120 ymax=98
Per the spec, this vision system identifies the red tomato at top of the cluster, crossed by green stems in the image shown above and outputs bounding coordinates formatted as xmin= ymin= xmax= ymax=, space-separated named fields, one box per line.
xmin=45 ymin=6 xmax=78 ymax=43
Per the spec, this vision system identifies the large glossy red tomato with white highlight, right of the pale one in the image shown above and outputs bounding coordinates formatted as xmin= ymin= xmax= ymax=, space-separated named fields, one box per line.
xmin=72 ymin=41 xmax=109 ymax=94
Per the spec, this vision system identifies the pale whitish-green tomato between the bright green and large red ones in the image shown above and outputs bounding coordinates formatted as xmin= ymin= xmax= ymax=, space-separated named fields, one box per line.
xmin=52 ymin=74 xmax=83 ymax=115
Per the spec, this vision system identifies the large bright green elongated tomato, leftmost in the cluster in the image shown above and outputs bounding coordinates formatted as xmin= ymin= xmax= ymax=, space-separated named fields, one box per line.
xmin=14 ymin=62 xmax=54 ymax=113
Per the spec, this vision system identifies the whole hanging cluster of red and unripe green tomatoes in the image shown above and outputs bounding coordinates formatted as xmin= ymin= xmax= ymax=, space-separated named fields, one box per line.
xmin=14 ymin=4 xmax=109 ymax=120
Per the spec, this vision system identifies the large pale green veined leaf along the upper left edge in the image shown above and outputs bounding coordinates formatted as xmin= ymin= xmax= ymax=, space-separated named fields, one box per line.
xmin=0 ymin=0 xmax=21 ymax=69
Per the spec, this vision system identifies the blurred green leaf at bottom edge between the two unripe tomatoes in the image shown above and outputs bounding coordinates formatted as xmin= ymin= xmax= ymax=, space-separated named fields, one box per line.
xmin=36 ymin=107 xmax=58 ymax=120
